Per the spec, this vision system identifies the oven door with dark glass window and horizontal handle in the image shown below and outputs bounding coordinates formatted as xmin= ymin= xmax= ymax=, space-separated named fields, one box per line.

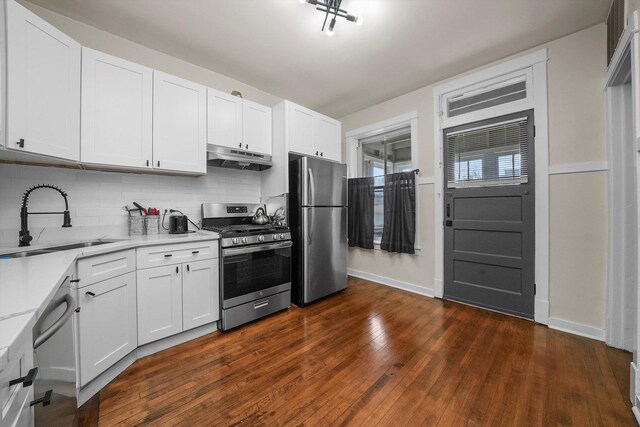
xmin=221 ymin=241 xmax=293 ymax=309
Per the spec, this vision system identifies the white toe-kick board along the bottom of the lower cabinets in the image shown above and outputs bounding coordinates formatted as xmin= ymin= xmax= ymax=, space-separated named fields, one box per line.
xmin=78 ymin=322 xmax=218 ymax=407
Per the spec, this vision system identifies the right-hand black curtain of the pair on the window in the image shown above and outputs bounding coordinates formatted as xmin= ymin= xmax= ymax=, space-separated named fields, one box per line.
xmin=380 ymin=171 xmax=416 ymax=254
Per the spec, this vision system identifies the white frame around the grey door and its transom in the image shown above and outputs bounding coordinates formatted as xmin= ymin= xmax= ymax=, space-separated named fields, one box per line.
xmin=433 ymin=48 xmax=549 ymax=324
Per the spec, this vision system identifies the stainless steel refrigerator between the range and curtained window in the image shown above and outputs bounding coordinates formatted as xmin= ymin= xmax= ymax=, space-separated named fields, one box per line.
xmin=289 ymin=156 xmax=347 ymax=307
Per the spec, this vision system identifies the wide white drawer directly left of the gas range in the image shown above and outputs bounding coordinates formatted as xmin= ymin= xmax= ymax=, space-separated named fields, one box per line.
xmin=137 ymin=241 xmax=218 ymax=269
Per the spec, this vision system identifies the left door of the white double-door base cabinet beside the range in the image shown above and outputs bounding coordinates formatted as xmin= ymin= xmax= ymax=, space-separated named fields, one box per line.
xmin=137 ymin=265 xmax=182 ymax=345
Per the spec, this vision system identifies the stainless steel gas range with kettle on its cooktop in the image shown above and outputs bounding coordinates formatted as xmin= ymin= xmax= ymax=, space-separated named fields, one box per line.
xmin=202 ymin=203 xmax=293 ymax=331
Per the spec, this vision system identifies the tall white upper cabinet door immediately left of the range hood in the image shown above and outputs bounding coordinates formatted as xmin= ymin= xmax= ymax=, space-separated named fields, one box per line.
xmin=153 ymin=71 xmax=207 ymax=174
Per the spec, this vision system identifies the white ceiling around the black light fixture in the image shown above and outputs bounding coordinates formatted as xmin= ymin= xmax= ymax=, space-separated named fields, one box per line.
xmin=30 ymin=0 xmax=611 ymax=118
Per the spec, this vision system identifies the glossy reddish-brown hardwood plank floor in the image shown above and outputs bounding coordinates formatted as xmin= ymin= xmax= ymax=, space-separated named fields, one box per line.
xmin=80 ymin=278 xmax=635 ymax=426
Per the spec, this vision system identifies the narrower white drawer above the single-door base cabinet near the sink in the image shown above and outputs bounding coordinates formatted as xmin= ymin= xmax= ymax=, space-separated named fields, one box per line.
xmin=78 ymin=249 xmax=136 ymax=287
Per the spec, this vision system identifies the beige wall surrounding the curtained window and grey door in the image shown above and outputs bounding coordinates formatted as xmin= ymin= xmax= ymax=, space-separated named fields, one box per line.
xmin=341 ymin=24 xmax=607 ymax=328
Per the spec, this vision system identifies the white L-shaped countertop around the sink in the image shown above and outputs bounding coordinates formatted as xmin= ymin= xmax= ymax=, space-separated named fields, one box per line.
xmin=0 ymin=231 xmax=220 ymax=349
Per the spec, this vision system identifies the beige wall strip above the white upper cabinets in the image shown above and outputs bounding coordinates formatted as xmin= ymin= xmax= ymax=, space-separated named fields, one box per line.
xmin=20 ymin=1 xmax=282 ymax=106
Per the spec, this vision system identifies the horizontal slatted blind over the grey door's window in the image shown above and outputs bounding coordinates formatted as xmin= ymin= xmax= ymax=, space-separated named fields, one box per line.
xmin=446 ymin=117 xmax=530 ymax=188
